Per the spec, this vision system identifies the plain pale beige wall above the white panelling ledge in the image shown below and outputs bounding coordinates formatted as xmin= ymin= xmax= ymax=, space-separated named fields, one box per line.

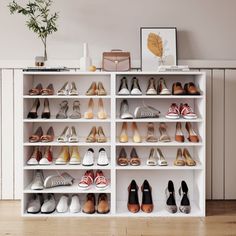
xmin=0 ymin=0 xmax=236 ymax=60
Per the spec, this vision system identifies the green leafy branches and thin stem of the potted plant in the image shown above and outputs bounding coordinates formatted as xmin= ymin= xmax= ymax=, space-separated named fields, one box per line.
xmin=8 ymin=0 xmax=59 ymax=61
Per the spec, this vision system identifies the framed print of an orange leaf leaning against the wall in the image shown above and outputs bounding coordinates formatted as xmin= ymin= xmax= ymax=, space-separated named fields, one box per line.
xmin=140 ymin=27 xmax=177 ymax=71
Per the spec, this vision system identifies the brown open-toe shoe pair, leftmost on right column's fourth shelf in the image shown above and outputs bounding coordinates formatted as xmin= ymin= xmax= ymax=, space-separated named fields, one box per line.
xmin=117 ymin=148 xmax=141 ymax=166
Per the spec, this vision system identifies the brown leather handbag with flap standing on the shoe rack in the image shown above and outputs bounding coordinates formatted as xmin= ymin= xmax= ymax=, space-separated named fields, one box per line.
xmin=102 ymin=49 xmax=131 ymax=71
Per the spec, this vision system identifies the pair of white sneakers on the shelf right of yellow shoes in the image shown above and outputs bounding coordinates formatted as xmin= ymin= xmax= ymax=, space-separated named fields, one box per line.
xmin=82 ymin=148 xmax=109 ymax=166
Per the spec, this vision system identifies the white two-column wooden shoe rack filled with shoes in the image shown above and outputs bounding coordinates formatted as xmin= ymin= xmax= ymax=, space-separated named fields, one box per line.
xmin=22 ymin=72 xmax=206 ymax=217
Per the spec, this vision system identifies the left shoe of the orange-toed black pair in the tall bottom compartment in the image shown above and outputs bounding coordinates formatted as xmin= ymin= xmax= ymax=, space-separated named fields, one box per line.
xmin=127 ymin=180 xmax=140 ymax=213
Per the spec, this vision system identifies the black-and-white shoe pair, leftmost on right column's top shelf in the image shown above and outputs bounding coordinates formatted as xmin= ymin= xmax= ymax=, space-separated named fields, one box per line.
xmin=118 ymin=77 xmax=142 ymax=95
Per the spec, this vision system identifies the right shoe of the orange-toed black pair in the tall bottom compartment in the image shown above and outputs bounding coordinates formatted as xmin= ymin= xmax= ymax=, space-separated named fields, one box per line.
xmin=141 ymin=179 xmax=154 ymax=213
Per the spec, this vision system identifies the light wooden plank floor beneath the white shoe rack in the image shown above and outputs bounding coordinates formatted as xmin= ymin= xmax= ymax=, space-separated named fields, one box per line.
xmin=0 ymin=201 xmax=236 ymax=236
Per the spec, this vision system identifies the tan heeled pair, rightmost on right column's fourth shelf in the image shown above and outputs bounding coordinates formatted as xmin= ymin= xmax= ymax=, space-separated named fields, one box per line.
xmin=174 ymin=148 xmax=196 ymax=166
